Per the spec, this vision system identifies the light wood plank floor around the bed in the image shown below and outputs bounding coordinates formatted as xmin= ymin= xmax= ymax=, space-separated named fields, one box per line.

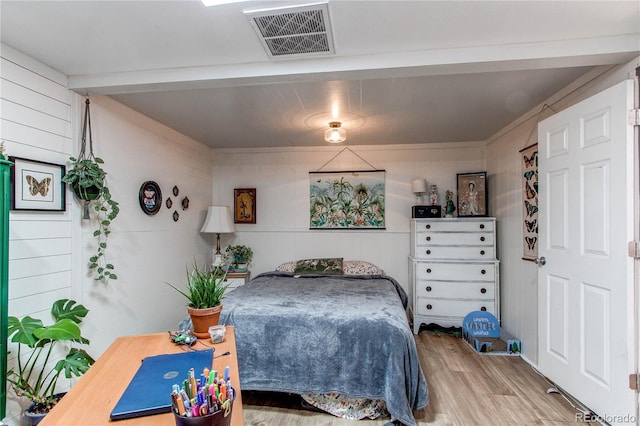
xmin=242 ymin=331 xmax=580 ymax=426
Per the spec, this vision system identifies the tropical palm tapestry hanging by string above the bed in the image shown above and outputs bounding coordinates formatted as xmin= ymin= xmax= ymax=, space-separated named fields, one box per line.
xmin=309 ymin=170 xmax=385 ymax=229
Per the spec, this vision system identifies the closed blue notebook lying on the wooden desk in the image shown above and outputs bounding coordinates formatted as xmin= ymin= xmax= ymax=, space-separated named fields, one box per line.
xmin=111 ymin=349 xmax=214 ymax=420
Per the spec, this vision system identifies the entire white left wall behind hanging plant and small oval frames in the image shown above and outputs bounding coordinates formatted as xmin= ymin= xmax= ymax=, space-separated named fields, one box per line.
xmin=0 ymin=45 xmax=218 ymax=425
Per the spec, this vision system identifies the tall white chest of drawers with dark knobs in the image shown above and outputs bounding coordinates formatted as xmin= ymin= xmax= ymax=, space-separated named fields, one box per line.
xmin=409 ymin=217 xmax=500 ymax=334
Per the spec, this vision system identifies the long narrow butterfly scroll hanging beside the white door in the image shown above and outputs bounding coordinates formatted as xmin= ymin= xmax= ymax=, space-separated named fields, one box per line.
xmin=520 ymin=144 xmax=538 ymax=261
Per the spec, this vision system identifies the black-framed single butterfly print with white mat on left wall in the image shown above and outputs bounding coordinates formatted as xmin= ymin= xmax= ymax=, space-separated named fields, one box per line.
xmin=9 ymin=157 xmax=66 ymax=211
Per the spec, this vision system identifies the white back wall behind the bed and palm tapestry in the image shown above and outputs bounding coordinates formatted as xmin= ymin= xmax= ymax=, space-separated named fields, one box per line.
xmin=214 ymin=142 xmax=485 ymax=292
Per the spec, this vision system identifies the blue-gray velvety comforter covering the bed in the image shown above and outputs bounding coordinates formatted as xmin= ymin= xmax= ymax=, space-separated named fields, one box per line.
xmin=220 ymin=272 xmax=429 ymax=425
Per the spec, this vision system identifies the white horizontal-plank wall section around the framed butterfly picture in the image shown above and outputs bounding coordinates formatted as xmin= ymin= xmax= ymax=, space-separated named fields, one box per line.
xmin=0 ymin=46 xmax=73 ymax=424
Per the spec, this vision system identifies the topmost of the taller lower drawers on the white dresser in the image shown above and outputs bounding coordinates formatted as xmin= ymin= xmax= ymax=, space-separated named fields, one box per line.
xmin=415 ymin=262 xmax=496 ymax=282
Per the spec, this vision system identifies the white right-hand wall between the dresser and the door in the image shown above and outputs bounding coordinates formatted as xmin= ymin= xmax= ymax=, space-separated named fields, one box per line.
xmin=487 ymin=58 xmax=640 ymax=365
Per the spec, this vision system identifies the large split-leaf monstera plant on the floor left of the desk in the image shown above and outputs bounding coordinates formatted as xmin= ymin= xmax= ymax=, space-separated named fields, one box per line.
xmin=7 ymin=299 xmax=95 ymax=425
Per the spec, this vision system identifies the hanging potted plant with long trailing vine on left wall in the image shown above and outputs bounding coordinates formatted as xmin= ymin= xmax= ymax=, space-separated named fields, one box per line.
xmin=62 ymin=99 xmax=120 ymax=282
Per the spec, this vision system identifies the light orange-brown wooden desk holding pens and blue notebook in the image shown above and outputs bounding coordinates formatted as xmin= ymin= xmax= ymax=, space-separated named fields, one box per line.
xmin=40 ymin=326 xmax=244 ymax=426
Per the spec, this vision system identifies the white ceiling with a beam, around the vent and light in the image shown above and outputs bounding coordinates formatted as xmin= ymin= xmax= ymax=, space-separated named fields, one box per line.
xmin=0 ymin=0 xmax=640 ymax=148
